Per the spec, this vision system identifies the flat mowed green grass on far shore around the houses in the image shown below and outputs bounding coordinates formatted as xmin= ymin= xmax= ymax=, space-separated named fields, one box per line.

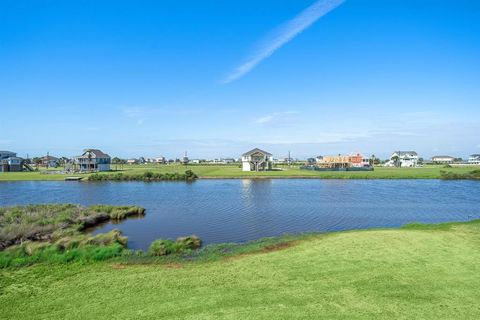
xmin=0 ymin=164 xmax=478 ymax=181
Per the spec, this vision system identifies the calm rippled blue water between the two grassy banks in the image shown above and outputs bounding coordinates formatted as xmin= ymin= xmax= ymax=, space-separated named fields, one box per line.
xmin=0 ymin=179 xmax=480 ymax=249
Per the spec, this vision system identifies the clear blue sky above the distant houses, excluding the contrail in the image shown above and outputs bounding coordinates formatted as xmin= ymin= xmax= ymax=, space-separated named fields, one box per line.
xmin=0 ymin=0 xmax=480 ymax=158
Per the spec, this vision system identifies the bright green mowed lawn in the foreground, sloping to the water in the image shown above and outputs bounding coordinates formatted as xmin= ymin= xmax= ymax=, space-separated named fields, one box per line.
xmin=0 ymin=221 xmax=480 ymax=319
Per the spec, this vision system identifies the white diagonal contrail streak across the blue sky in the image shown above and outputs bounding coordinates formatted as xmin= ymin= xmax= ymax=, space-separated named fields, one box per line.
xmin=223 ymin=0 xmax=345 ymax=83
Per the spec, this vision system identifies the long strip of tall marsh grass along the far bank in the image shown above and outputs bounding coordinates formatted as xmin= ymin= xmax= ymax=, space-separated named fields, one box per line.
xmin=88 ymin=170 xmax=198 ymax=182
